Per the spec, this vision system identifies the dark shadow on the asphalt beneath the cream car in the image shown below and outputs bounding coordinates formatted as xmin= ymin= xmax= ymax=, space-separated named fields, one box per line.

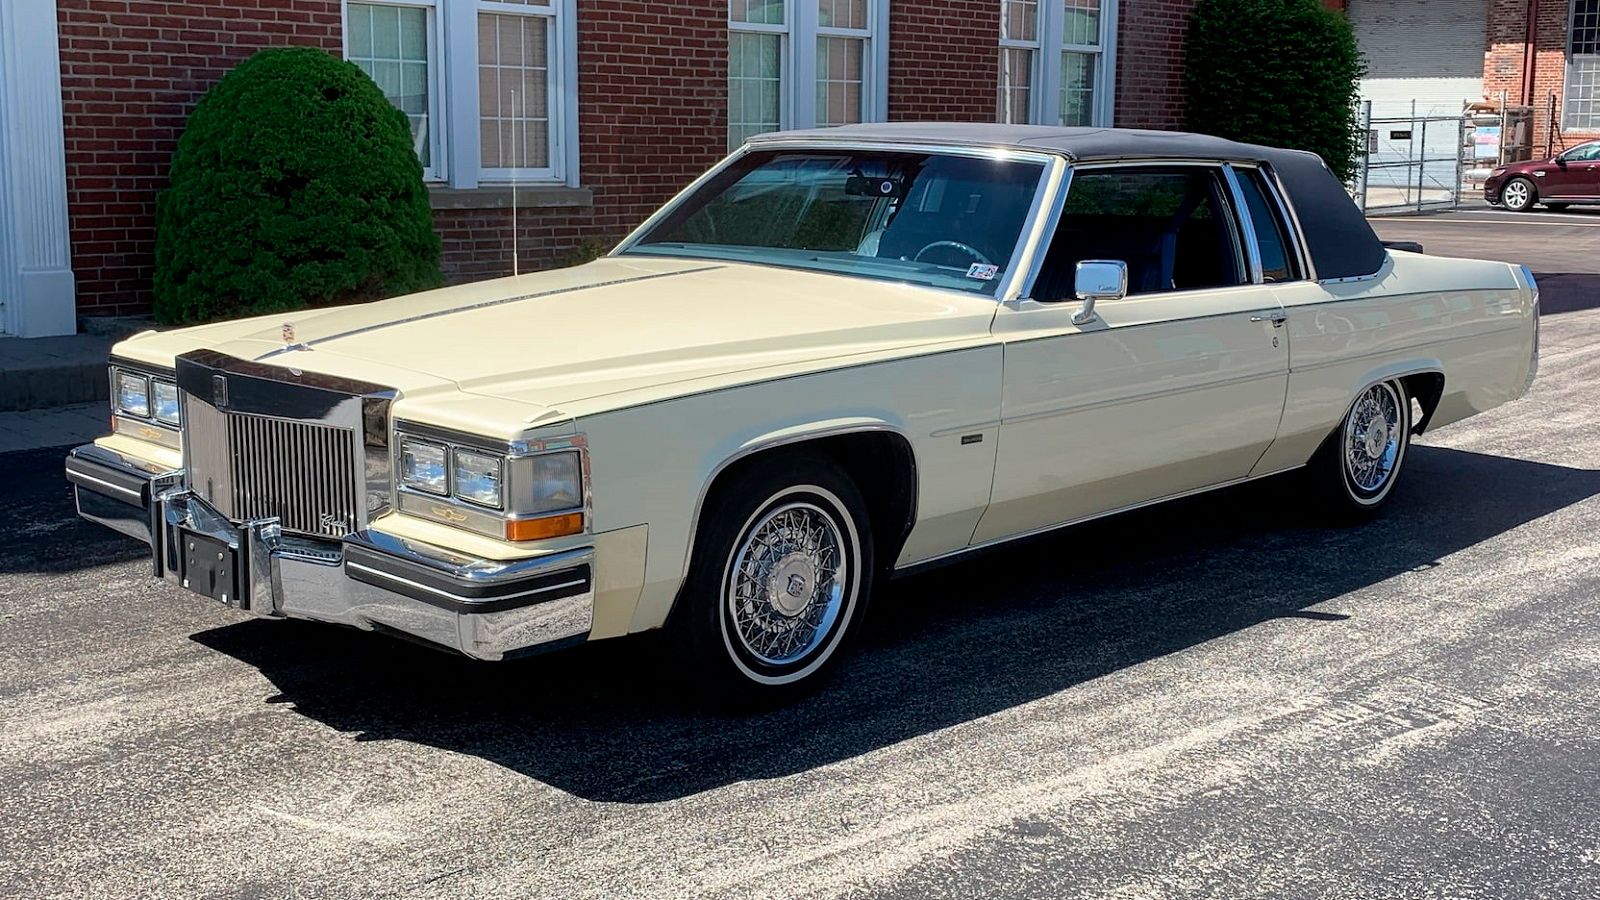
xmin=194 ymin=447 xmax=1600 ymax=802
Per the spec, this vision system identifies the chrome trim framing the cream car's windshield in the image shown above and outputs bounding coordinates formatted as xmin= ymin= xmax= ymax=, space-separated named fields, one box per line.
xmin=608 ymin=138 xmax=1070 ymax=303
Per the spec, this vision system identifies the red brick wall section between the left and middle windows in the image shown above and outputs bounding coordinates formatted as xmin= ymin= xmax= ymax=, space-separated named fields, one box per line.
xmin=434 ymin=0 xmax=728 ymax=282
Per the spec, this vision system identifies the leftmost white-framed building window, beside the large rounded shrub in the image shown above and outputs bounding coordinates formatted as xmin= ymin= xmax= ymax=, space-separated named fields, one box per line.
xmin=344 ymin=0 xmax=578 ymax=187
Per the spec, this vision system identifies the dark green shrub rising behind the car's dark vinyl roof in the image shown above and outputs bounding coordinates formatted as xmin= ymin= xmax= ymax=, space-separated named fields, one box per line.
xmin=1184 ymin=0 xmax=1365 ymax=181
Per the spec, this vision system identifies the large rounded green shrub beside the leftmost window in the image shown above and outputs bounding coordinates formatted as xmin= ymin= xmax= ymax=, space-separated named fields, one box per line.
xmin=155 ymin=48 xmax=442 ymax=323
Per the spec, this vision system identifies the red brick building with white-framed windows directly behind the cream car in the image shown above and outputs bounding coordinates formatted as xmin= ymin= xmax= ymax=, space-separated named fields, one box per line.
xmin=0 ymin=0 xmax=1192 ymax=335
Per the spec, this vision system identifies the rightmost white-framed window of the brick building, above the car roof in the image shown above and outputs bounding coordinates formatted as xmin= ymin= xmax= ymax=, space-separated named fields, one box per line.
xmin=995 ymin=0 xmax=1117 ymax=125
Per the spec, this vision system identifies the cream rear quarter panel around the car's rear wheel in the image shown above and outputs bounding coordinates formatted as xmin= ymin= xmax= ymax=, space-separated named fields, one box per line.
xmin=1256 ymin=250 xmax=1536 ymax=472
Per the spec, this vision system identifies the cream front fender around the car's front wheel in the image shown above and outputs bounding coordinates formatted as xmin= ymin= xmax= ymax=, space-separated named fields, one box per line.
xmin=578 ymin=344 xmax=1002 ymax=637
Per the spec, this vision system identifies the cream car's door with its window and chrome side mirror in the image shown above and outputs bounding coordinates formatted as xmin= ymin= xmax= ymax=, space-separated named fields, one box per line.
xmin=973 ymin=165 xmax=1288 ymax=543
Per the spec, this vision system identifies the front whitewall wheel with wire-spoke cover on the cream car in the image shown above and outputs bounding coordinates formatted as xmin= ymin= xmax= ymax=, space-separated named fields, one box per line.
xmin=672 ymin=456 xmax=874 ymax=705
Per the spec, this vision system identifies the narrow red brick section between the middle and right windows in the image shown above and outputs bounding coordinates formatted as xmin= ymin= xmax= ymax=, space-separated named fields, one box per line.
xmin=890 ymin=0 xmax=1000 ymax=122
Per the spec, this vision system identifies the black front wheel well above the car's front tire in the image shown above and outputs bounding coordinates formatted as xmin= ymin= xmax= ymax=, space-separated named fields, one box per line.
xmin=694 ymin=431 xmax=917 ymax=565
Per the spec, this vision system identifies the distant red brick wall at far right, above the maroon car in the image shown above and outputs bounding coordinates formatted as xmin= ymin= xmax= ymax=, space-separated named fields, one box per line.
xmin=1483 ymin=0 xmax=1595 ymax=157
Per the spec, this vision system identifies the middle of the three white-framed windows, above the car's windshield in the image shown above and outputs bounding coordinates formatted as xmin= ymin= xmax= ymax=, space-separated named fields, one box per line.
xmin=728 ymin=0 xmax=888 ymax=149
